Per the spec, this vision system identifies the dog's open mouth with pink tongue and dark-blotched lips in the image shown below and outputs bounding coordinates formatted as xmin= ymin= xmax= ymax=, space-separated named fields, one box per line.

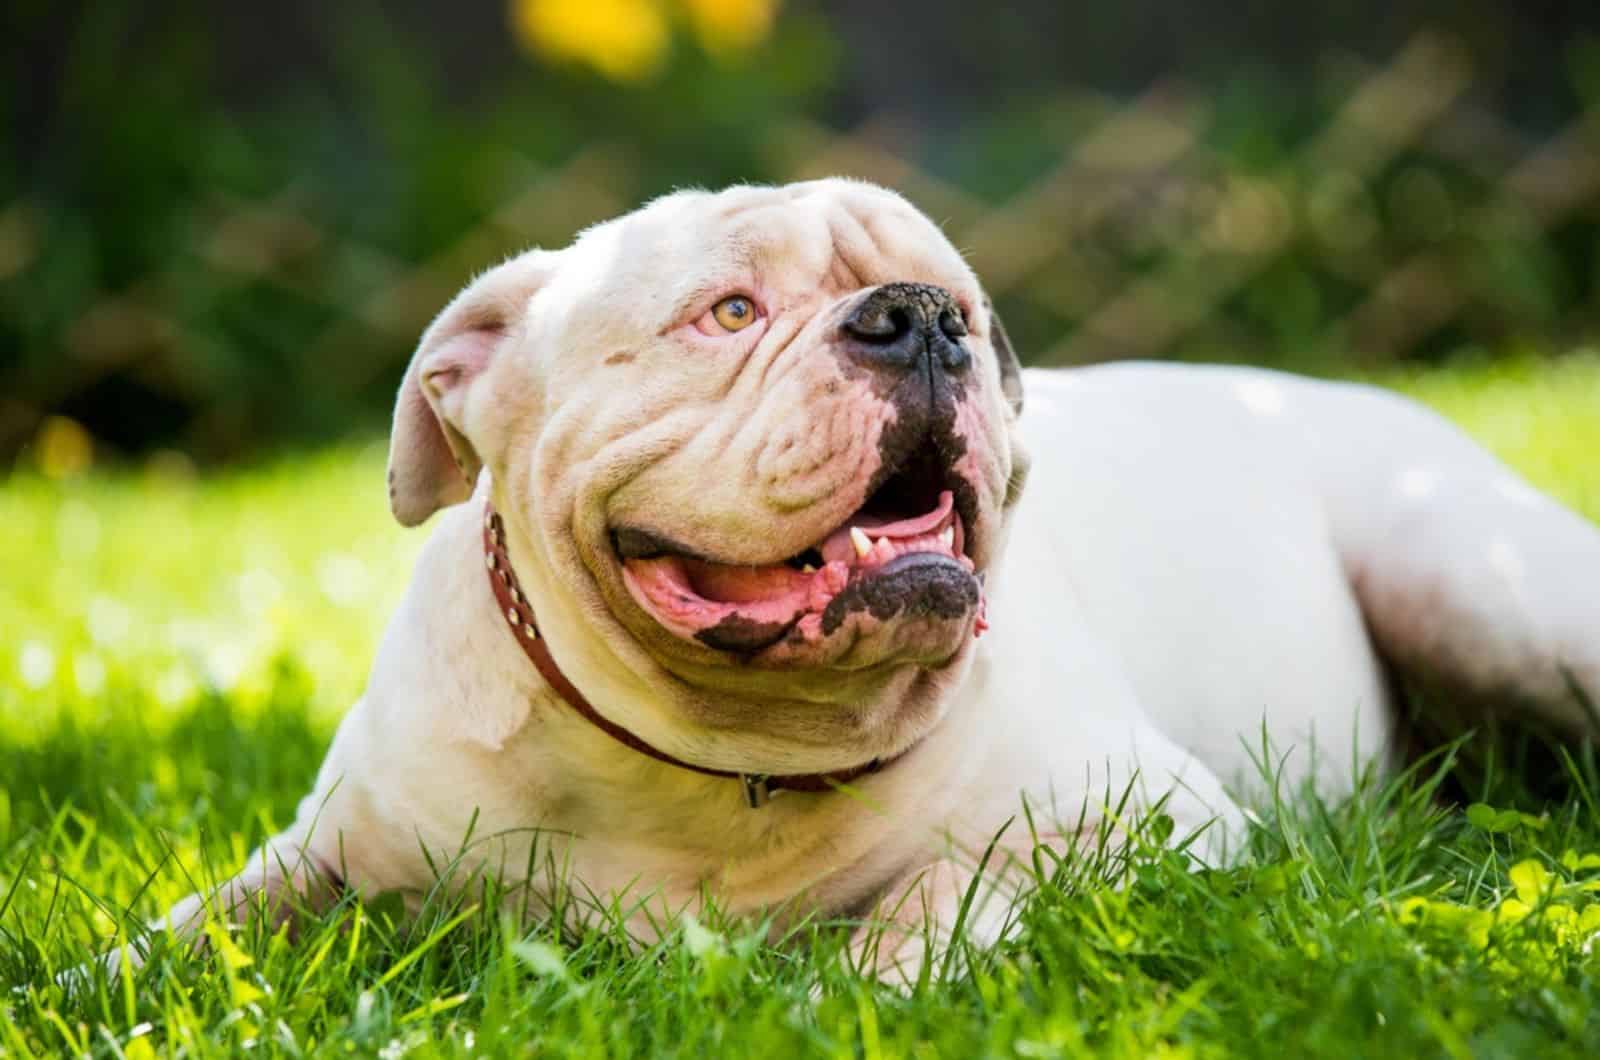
xmin=613 ymin=457 xmax=982 ymax=653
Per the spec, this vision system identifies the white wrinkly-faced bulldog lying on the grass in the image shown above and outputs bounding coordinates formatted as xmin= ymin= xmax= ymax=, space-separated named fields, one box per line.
xmin=134 ymin=179 xmax=1600 ymax=975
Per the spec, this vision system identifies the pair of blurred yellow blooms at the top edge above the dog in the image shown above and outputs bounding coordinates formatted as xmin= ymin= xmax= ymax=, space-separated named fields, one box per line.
xmin=510 ymin=0 xmax=779 ymax=82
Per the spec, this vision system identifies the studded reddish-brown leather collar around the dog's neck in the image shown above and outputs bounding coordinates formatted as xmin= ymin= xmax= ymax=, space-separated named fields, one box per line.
xmin=483 ymin=501 xmax=904 ymax=809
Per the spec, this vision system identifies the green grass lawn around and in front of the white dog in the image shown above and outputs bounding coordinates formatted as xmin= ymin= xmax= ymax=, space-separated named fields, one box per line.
xmin=0 ymin=355 xmax=1600 ymax=1058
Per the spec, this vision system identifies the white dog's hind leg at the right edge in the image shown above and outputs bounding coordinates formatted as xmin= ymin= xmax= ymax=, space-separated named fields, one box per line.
xmin=1302 ymin=384 xmax=1600 ymax=738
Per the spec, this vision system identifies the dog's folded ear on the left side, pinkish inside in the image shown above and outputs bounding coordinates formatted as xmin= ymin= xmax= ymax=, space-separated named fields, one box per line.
xmin=389 ymin=251 xmax=557 ymax=527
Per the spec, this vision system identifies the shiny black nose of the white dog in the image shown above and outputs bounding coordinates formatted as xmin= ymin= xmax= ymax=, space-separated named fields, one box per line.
xmin=838 ymin=283 xmax=973 ymax=373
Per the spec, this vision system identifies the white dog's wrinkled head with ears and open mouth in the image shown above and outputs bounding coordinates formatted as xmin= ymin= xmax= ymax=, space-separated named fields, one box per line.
xmin=389 ymin=179 xmax=1024 ymax=769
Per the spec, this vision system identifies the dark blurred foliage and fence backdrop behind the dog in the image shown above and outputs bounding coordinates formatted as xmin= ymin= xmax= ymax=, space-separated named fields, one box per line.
xmin=0 ymin=0 xmax=1600 ymax=477
